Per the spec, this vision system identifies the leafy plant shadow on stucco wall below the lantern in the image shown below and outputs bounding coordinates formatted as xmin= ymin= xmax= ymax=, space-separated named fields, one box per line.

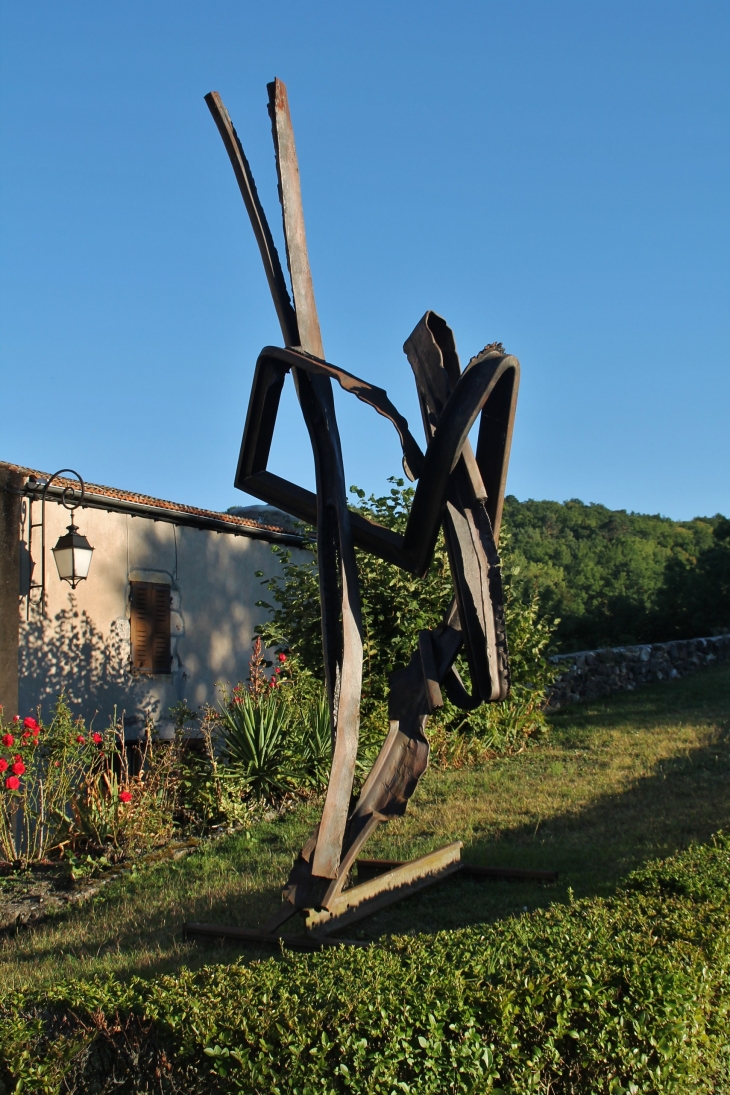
xmin=19 ymin=593 xmax=159 ymax=725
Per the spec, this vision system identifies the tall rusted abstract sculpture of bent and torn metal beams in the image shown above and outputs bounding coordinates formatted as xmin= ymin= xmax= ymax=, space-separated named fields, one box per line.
xmin=188 ymin=80 xmax=520 ymax=941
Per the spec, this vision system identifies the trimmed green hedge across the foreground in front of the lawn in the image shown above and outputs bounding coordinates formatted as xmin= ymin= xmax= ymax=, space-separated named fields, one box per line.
xmin=0 ymin=834 xmax=730 ymax=1095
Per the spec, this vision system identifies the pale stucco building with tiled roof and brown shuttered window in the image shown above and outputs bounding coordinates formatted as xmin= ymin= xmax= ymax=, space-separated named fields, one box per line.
xmin=0 ymin=462 xmax=302 ymax=738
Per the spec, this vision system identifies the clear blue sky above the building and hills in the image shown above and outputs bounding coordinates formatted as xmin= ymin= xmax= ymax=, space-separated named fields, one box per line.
xmin=0 ymin=0 xmax=730 ymax=518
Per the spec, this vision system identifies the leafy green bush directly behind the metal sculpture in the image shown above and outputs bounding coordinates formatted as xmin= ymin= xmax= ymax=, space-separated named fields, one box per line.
xmin=253 ymin=479 xmax=555 ymax=757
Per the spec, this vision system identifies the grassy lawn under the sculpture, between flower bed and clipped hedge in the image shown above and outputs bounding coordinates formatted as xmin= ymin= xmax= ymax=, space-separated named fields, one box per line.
xmin=0 ymin=667 xmax=730 ymax=990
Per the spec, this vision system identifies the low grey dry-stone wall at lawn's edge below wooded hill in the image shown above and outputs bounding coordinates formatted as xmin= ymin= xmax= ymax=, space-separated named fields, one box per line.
xmin=548 ymin=635 xmax=730 ymax=708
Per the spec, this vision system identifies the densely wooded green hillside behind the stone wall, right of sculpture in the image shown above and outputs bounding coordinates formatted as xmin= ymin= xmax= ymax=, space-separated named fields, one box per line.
xmin=503 ymin=495 xmax=730 ymax=652
